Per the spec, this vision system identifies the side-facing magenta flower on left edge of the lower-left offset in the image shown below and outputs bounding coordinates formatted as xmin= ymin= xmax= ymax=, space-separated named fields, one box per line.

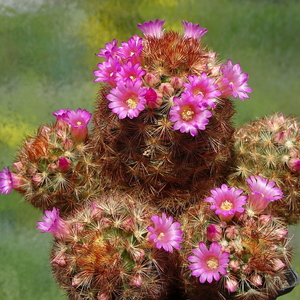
xmin=36 ymin=207 xmax=70 ymax=238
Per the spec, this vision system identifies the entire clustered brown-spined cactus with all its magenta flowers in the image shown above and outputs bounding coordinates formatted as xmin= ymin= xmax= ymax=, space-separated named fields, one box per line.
xmin=0 ymin=20 xmax=300 ymax=300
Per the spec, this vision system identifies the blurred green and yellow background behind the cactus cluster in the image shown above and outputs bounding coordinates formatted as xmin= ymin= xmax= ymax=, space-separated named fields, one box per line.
xmin=0 ymin=0 xmax=300 ymax=300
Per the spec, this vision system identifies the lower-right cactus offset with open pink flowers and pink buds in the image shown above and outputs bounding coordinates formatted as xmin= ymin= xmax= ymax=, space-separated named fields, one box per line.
xmin=180 ymin=178 xmax=291 ymax=300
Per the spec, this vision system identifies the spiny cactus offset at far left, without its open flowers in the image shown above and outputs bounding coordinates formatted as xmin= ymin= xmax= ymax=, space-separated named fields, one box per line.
xmin=13 ymin=109 xmax=103 ymax=214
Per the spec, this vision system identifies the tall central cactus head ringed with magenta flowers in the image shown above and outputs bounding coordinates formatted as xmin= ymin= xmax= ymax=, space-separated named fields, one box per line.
xmin=92 ymin=20 xmax=251 ymax=209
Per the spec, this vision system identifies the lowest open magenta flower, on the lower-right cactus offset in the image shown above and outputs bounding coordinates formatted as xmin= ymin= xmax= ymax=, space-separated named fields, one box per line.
xmin=188 ymin=242 xmax=230 ymax=283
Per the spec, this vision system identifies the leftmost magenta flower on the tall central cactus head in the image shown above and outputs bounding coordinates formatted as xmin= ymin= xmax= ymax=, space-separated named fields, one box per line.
xmin=94 ymin=57 xmax=121 ymax=87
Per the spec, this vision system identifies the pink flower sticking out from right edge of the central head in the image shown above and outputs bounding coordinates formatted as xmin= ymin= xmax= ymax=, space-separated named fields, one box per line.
xmin=217 ymin=59 xmax=252 ymax=100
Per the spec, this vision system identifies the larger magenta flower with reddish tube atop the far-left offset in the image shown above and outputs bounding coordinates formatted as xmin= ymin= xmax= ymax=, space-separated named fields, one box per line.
xmin=64 ymin=108 xmax=92 ymax=142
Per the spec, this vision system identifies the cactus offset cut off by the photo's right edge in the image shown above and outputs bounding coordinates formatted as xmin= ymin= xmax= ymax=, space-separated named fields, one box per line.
xmin=229 ymin=114 xmax=300 ymax=224
